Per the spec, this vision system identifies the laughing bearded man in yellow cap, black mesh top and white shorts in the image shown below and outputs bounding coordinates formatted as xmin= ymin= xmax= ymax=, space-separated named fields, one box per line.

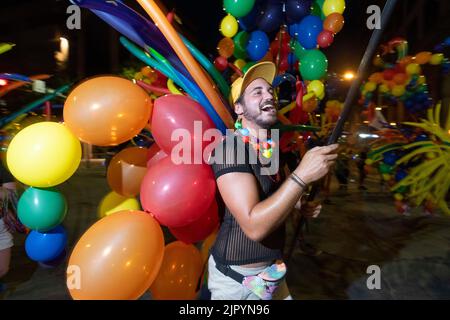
xmin=208 ymin=62 xmax=337 ymax=300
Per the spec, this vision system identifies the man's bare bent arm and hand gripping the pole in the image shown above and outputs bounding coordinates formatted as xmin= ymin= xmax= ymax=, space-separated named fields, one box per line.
xmin=217 ymin=145 xmax=336 ymax=241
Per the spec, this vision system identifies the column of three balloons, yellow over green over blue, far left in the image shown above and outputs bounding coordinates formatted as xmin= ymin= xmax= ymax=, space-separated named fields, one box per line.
xmin=6 ymin=122 xmax=81 ymax=263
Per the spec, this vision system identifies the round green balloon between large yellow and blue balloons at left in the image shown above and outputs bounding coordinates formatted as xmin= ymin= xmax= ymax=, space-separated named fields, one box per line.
xmin=17 ymin=187 xmax=67 ymax=232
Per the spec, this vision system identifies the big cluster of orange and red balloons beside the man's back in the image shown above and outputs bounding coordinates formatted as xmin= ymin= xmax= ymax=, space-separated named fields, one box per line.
xmin=59 ymin=76 xmax=219 ymax=299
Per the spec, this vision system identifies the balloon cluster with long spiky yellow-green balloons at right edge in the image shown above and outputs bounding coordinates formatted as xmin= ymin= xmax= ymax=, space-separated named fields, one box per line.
xmin=366 ymin=105 xmax=450 ymax=214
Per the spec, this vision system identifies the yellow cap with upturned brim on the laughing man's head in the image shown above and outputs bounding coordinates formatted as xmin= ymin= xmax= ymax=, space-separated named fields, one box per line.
xmin=231 ymin=61 xmax=277 ymax=104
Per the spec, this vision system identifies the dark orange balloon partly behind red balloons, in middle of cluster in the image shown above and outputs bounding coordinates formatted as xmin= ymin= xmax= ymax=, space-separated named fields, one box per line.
xmin=106 ymin=147 xmax=148 ymax=197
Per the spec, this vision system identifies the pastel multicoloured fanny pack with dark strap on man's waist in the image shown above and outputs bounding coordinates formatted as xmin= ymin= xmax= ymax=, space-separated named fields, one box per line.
xmin=216 ymin=262 xmax=286 ymax=300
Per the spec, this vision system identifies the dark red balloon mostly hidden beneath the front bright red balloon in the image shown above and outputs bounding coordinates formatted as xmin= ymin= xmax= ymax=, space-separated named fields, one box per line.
xmin=169 ymin=201 xmax=219 ymax=243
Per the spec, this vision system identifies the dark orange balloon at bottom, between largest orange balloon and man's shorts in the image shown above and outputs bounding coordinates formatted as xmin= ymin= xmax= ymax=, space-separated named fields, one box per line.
xmin=150 ymin=241 xmax=203 ymax=300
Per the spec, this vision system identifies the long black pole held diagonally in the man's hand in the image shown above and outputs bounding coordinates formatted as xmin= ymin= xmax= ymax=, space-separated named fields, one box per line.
xmin=287 ymin=0 xmax=397 ymax=261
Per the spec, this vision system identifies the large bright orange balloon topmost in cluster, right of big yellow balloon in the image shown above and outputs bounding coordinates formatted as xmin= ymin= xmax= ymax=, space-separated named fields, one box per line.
xmin=64 ymin=76 xmax=151 ymax=146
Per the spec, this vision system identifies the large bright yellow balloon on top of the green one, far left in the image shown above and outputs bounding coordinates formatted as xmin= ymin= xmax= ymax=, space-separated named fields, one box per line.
xmin=6 ymin=122 xmax=81 ymax=188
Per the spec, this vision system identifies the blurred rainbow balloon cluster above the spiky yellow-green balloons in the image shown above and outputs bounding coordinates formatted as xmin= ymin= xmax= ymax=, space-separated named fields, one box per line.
xmin=360 ymin=38 xmax=446 ymax=120
